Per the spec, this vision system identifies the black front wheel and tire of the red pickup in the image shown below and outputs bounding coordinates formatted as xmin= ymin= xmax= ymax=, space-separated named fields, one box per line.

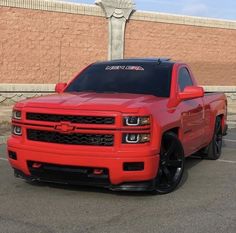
xmin=154 ymin=132 xmax=185 ymax=194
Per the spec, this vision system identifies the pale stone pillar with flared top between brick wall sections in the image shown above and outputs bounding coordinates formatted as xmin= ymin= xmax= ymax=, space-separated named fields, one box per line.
xmin=95 ymin=0 xmax=135 ymax=60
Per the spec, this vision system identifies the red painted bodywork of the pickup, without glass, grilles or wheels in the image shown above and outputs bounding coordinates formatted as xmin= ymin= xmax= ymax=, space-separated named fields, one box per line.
xmin=7 ymin=63 xmax=227 ymax=185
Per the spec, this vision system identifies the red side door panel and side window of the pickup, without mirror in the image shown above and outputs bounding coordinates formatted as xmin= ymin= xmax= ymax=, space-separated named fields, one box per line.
xmin=178 ymin=66 xmax=204 ymax=154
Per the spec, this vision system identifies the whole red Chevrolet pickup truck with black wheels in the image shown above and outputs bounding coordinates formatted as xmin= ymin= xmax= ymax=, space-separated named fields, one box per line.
xmin=7 ymin=58 xmax=227 ymax=194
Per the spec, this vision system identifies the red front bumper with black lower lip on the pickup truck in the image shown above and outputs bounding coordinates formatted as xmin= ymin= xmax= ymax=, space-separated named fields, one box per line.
xmin=8 ymin=137 xmax=160 ymax=191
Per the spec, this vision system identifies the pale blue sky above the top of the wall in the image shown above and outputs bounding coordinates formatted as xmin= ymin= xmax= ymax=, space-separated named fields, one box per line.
xmin=58 ymin=0 xmax=236 ymax=20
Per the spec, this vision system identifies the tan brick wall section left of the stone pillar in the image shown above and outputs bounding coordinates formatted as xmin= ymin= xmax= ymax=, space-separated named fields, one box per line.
xmin=0 ymin=7 xmax=108 ymax=83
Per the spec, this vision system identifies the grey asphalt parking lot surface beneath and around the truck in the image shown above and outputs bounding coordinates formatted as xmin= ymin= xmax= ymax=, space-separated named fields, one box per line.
xmin=0 ymin=130 xmax=236 ymax=233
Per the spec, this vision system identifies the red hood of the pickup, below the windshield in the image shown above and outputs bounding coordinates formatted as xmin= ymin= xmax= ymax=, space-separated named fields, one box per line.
xmin=16 ymin=92 xmax=163 ymax=112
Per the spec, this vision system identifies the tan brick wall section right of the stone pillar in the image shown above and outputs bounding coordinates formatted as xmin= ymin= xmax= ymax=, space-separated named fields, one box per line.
xmin=125 ymin=20 xmax=236 ymax=86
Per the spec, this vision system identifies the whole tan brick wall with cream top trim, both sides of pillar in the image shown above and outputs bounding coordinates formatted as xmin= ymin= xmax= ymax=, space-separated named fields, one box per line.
xmin=0 ymin=0 xmax=236 ymax=86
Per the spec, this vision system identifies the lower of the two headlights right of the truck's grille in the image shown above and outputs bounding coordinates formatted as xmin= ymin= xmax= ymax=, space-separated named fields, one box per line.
xmin=122 ymin=133 xmax=151 ymax=144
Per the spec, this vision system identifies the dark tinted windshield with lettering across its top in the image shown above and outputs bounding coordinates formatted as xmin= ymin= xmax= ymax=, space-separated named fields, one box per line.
xmin=65 ymin=62 xmax=172 ymax=97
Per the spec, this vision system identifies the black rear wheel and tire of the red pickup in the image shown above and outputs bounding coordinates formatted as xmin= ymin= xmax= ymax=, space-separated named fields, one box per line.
xmin=205 ymin=117 xmax=223 ymax=160
